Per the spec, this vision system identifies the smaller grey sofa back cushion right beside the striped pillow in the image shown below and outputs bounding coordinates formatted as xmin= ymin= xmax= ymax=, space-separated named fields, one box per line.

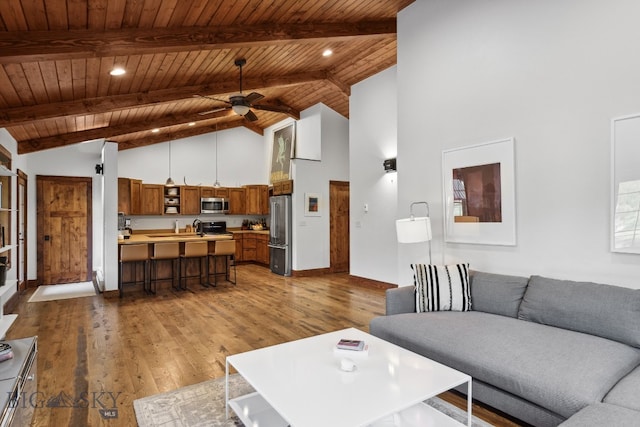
xmin=469 ymin=271 xmax=529 ymax=317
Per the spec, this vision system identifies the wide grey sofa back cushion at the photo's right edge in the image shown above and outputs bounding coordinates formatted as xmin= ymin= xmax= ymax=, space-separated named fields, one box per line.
xmin=518 ymin=276 xmax=640 ymax=347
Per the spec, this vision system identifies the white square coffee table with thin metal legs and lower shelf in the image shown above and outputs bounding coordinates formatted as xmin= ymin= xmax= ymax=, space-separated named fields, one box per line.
xmin=225 ymin=328 xmax=471 ymax=427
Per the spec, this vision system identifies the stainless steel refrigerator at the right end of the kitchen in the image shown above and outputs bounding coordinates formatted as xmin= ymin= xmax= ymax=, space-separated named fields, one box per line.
xmin=269 ymin=196 xmax=291 ymax=276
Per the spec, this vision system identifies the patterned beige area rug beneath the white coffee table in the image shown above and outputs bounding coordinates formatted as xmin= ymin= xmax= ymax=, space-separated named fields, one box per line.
xmin=133 ymin=374 xmax=491 ymax=427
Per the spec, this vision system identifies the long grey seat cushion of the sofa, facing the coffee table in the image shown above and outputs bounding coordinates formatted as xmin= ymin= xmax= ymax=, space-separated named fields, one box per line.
xmin=369 ymin=311 xmax=640 ymax=418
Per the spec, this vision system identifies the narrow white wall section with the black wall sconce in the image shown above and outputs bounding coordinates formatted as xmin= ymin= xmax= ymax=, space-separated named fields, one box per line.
xmin=349 ymin=67 xmax=402 ymax=283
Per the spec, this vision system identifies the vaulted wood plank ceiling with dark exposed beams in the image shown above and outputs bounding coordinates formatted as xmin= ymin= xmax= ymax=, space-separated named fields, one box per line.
xmin=0 ymin=0 xmax=413 ymax=154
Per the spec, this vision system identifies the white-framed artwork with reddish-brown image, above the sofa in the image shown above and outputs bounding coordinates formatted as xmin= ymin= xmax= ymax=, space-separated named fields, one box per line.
xmin=442 ymin=138 xmax=516 ymax=246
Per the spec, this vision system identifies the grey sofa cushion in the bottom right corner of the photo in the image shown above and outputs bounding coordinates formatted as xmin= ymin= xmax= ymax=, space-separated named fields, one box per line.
xmin=558 ymin=403 xmax=640 ymax=427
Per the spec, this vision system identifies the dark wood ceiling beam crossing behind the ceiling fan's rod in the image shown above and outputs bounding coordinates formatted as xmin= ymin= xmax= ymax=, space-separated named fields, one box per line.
xmin=0 ymin=71 xmax=328 ymax=127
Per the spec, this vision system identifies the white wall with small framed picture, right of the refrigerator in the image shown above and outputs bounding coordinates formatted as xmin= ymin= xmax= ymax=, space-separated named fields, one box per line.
xmin=264 ymin=104 xmax=349 ymax=271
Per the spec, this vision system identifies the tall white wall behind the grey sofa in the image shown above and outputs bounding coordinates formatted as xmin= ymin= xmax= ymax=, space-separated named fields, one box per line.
xmin=398 ymin=0 xmax=640 ymax=288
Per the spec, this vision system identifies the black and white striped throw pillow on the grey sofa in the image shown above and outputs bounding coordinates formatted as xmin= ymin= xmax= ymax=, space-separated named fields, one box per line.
xmin=411 ymin=264 xmax=471 ymax=313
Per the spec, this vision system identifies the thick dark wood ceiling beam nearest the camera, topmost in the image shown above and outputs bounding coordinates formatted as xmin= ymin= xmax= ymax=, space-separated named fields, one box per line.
xmin=0 ymin=19 xmax=396 ymax=64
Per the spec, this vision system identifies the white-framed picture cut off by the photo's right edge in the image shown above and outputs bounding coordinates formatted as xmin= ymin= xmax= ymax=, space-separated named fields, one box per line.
xmin=611 ymin=114 xmax=640 ymax=254
